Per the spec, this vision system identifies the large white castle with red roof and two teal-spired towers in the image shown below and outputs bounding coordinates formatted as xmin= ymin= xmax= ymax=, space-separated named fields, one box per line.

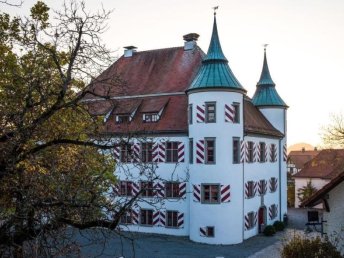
xmin=85 ymin=13 xmax=287 ymax=244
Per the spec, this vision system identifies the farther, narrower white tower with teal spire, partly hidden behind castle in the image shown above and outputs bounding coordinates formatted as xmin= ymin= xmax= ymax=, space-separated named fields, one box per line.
xmin=252 ymin=46 xmax=288 ymax=220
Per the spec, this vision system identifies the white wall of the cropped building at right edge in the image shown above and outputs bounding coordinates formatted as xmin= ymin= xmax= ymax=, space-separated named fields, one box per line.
xmin=323 ymin=182 xmax=344 ymax=255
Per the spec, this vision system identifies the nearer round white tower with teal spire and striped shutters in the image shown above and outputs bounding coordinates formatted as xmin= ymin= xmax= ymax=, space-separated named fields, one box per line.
xmin=186 ymin=13 xmax=246 ymax=244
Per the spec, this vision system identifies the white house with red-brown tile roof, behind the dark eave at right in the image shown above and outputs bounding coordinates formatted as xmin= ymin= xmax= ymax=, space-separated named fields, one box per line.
xmin=293 ymin=149 xmax=344 ymax=207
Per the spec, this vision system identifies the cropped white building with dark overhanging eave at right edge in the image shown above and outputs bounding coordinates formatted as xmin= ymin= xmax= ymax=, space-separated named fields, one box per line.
xmin=301 ymin=170 xmax=344 ymax=254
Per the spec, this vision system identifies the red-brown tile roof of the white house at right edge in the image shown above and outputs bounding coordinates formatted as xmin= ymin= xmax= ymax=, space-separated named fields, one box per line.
xmin=294 ymin=149 xmax=344 ymax=179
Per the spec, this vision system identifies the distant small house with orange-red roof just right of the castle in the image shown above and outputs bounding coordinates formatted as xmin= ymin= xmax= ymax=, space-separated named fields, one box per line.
xmin=287 ymin=148 xmax=319 ymax=175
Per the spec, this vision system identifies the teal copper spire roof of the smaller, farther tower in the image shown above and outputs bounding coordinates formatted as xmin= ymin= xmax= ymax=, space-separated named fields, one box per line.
xmin=252 ymin=48 xmax=288 ymax=107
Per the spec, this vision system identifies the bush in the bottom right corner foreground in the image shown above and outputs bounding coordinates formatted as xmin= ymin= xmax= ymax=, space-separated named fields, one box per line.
xmin=282 ymin=236 xmax=343 ymax=258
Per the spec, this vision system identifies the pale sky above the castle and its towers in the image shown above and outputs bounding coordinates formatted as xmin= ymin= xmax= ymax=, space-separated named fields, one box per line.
xmin=0 ymin=0 xmax=344 ymax=148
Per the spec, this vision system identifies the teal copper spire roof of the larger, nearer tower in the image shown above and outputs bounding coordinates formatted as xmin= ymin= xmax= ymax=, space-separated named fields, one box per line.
xmin=187 ymin=15 xmax=246 ymax=92
